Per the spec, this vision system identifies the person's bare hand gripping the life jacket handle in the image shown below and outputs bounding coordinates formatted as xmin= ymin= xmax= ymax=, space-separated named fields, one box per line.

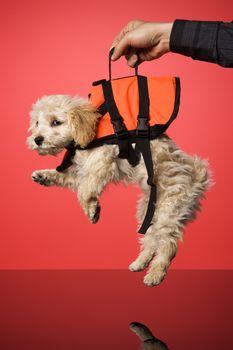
xmin=112 ymin=20 xmax=173 ymax=67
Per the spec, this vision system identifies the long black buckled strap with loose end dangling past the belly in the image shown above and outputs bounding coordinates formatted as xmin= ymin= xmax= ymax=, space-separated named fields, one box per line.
xmin=135 ymin=76 xmax=157 ymax=234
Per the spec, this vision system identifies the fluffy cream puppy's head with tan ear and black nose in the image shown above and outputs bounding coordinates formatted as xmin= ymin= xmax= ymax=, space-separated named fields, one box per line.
xmin=27 ymin=95 xmax=100 ymax=155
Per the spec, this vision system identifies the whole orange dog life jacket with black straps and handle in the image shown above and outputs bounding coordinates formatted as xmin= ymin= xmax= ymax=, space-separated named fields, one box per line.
xmin=57 ymin=49 xmax=180 ymax=234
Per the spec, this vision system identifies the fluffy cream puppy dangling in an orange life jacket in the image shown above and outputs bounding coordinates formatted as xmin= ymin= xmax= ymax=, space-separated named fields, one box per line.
xmin=27 ymin=95 xmax=212 ymax=286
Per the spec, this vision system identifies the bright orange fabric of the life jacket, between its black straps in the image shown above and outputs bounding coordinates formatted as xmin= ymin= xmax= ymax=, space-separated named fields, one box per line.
xmin=90 ymin=76 xmax=176 ymax=138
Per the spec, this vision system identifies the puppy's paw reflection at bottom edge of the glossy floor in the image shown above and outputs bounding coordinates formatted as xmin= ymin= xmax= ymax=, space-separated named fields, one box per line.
xmin=129 ymin=322 xmax=169 ymax=350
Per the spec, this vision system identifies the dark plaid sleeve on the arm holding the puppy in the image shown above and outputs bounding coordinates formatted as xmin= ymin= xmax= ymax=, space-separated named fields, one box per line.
xmin=170 ymin=20 xmax=233 ymax=67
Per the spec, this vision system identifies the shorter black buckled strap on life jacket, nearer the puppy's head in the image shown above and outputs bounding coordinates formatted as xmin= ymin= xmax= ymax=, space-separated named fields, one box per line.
xmin=102 ymin=80 xmax=139 ymax=166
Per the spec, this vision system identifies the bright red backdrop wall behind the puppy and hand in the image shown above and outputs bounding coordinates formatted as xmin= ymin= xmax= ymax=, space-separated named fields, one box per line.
xmin=0 ymin=0 xmax=233 ymax=269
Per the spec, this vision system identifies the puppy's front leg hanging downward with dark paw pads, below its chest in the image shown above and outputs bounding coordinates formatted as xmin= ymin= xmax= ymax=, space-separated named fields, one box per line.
xmin=77 ymin=146 xmax=118 ymax=224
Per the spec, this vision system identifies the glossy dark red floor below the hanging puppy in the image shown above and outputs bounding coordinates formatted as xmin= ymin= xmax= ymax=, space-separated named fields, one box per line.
xmin=0 ymin=270 xmax=233 ymax=350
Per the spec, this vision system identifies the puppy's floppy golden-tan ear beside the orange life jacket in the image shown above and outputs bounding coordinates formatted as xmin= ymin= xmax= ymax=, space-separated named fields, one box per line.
xmin=68 ymin=102 xmax=100 ymax=148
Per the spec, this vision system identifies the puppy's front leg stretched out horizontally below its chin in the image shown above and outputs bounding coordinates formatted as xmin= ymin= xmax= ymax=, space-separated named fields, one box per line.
xmin=32 ymin=169 xmax=74 ymax=188
